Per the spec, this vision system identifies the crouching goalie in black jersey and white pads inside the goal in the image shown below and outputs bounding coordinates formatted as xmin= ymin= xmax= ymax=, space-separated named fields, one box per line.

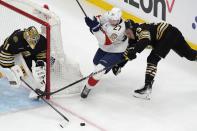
xmin=0 ymin=26 xmax=46 ymax=98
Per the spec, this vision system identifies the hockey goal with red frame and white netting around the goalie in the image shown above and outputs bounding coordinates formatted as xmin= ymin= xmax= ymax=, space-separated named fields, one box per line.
xmin=0 ymin=0 xmax=82 ymax=98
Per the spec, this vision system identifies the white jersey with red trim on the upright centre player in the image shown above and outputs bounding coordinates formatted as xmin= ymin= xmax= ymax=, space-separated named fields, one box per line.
xmin=93 ymin=12 xmax=128 ymax=53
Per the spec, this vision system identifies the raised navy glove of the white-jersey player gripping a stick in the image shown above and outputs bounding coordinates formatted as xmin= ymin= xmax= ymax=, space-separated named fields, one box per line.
xmin=85 ymin=17 xmax=100 ymax=32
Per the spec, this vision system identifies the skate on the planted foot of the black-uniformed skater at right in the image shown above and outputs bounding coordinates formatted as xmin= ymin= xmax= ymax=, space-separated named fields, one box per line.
xmin=133 ymin=82 xmax=153 ymax=100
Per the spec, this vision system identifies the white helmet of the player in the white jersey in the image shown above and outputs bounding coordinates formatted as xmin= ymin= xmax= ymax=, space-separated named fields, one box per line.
xmin=108 ymin=7 xmax=122 ymax=20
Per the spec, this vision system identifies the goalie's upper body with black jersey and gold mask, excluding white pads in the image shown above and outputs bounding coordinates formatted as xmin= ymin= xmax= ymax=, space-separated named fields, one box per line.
xmin=0 ymin=26 xmax=46 ymax=70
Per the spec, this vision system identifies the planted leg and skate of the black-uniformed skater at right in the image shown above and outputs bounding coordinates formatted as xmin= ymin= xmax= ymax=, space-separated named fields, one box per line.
xmin=134 ymin=27 xmax=175 ymax=99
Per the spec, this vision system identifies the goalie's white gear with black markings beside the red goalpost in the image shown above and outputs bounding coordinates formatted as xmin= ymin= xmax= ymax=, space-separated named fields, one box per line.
xmin=29 ymin=60 xmax=46 ymax=99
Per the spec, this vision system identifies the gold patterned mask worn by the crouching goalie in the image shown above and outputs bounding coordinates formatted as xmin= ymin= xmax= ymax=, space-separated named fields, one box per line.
xmin=24 ymin=26 xmax=40 ymax=49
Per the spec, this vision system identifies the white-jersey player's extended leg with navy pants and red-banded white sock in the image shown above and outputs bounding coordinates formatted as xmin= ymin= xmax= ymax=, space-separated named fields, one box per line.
xmin=81 ymin=53 xmax=123 ymax=98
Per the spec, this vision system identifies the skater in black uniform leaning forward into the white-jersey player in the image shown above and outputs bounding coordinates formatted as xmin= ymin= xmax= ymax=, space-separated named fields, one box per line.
xmin=125 ymin=20 xmax=197 ymax=99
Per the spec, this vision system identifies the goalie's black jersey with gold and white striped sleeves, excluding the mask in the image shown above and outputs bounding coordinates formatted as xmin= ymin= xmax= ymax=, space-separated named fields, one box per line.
xmin=0 ymin=30 xmax=47 ymax=67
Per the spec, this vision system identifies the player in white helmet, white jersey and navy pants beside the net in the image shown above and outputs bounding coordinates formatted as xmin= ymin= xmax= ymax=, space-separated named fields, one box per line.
xmin=81 ymin=8 xmax=128 ymax=98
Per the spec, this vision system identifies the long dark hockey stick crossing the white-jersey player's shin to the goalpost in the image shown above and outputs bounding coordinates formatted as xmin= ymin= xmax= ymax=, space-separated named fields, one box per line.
xmin=38 ymin=59 xmax=128 ymax=98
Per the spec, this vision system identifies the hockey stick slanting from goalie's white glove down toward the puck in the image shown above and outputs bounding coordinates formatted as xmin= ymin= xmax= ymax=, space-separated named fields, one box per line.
xmin=21 ymin=78 xmax=69 ymax=122
